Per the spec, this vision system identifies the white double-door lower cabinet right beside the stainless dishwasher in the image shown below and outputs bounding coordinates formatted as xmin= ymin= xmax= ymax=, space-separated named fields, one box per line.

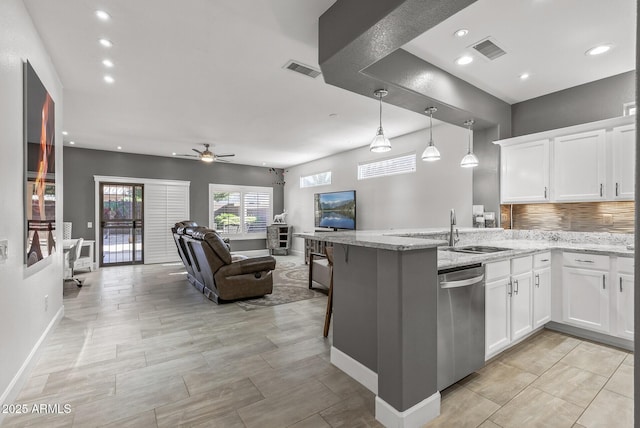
xmin=485 ymin=256 xmax=533 ymax=359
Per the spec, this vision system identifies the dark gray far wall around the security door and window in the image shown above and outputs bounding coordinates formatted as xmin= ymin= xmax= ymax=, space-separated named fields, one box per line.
xmin=64 ymin=147 xmax=284 ymax=251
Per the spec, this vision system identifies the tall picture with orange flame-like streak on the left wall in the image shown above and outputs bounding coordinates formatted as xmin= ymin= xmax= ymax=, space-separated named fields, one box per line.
xmin=23 ymin=61 xmax=56 ymax=266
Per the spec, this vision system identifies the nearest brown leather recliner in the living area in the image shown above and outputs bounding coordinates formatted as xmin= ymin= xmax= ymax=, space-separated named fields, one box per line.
xmin=183 ymin=230 xmax=276 ymax=303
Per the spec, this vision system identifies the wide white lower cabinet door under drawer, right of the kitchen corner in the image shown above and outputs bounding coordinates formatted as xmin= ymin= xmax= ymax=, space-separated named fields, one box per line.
xmin=562 ymin=267 xmax=611 ymax=333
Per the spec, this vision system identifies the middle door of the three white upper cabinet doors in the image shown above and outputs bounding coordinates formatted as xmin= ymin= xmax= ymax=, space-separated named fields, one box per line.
xmin=552 ymin=129 xmax=606 ymax=201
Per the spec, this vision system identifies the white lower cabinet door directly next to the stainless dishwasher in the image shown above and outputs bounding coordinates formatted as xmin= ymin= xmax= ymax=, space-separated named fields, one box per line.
xmin=485 ymin=278 xmax=510 ymax=359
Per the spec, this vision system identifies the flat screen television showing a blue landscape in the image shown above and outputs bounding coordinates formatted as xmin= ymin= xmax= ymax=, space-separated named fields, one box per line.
xmin=314 ymin=190 xmax=356 ymax=230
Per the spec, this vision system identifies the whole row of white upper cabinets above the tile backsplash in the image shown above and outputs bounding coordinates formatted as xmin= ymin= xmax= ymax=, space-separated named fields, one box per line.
xmin=495 ymin=116 xmax=635 ymax=204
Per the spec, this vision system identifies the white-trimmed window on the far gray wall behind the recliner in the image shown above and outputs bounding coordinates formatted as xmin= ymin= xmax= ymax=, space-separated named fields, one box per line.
xmin=209 ymin=184 xmax=273 ymax=239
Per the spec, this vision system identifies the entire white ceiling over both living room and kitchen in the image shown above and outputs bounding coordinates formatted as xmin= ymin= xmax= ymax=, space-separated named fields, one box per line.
xmin=24 ymin=0 xmax=635 ymax=167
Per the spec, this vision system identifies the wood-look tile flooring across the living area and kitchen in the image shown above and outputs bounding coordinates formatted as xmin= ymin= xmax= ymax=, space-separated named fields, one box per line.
xmin=2 ymin=256 xmax=633 ymax=428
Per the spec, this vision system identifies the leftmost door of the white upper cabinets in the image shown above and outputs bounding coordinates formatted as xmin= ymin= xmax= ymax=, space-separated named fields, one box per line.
xmin=500 ymin=140 xmax=549 ymax=203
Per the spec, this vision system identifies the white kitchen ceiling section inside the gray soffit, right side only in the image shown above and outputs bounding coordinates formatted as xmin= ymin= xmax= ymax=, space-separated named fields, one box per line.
xmin=404 ymin=0 xmax=636 ymax=104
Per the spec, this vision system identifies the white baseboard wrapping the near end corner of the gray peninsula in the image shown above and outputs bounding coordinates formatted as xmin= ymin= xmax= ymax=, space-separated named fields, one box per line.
xmin=376 ymin=391 xmax=440 ymax=428
